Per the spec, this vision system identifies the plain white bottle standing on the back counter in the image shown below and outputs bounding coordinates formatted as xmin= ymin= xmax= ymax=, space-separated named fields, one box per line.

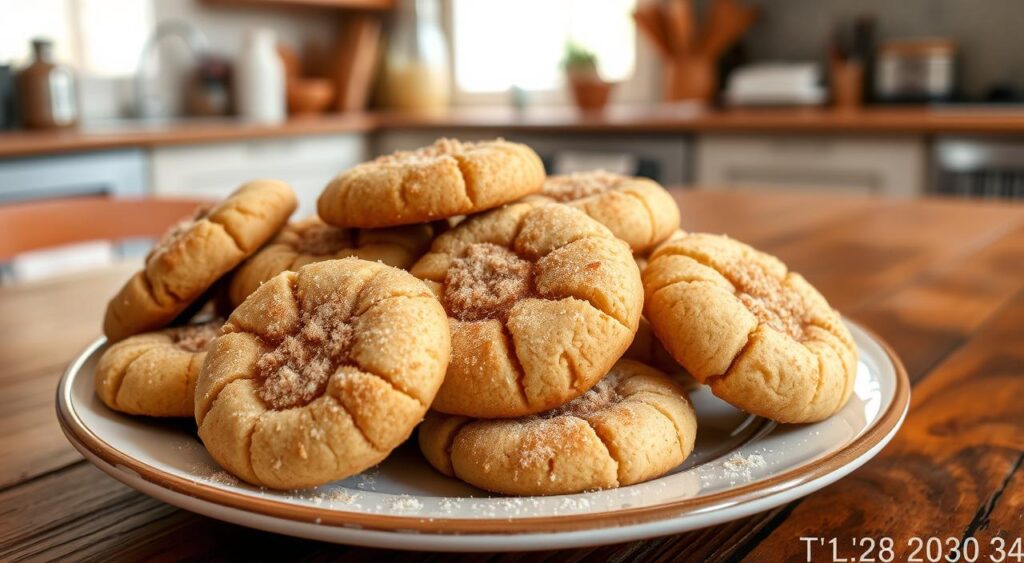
xmin=234 ymin=28 xmax=287 ymax=123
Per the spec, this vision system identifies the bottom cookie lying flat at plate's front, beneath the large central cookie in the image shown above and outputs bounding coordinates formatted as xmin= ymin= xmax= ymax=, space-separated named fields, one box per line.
xmin=420 ymin=359 xmax=696 ymax=494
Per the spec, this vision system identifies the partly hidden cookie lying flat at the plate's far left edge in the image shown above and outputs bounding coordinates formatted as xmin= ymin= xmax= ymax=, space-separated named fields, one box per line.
xmin=95 ymin=319 xmax=223 ymax=417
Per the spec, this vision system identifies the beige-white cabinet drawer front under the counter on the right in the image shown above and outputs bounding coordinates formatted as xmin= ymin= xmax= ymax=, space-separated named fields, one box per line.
xmin=695 ymin=134 xmax=928 ymax=196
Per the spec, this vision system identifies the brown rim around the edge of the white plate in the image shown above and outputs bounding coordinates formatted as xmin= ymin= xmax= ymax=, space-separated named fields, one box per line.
xmin=56 ymin=319 xmax=910 ymax=534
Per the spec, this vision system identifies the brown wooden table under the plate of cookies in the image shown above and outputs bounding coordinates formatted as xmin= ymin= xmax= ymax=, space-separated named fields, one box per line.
xmin=0 ymin=191 xmax=1024 ymax=562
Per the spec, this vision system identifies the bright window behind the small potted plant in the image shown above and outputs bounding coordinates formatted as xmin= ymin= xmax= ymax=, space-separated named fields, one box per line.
xmin=451 ymin=0 xmax=636 ymax=101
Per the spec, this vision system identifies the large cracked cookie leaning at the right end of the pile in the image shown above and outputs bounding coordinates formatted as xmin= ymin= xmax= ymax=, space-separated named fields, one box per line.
xmin=643 ymin=234 xmax=857 ymax=423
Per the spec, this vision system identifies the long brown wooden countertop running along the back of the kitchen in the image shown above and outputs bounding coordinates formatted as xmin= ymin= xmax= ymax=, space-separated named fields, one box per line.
xmin=9 ymin=103 xmax=1024 ymax=158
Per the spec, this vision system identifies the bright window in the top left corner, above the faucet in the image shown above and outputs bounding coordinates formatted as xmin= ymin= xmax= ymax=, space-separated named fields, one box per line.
xmin=0 ymin=0 xmax=153 ymax=77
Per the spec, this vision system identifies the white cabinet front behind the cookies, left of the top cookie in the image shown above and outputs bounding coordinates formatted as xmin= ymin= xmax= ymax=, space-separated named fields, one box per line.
xmin=151 ymin=134 xmax=367 ymax=217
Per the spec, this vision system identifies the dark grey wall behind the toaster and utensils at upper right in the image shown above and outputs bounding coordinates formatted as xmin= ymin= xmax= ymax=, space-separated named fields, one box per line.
xmin=745 ymin=0 xmax=1024 ymax=98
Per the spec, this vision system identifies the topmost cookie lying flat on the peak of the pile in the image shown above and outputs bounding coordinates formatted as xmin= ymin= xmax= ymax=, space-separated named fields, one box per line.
xmin=316 ymin=139 xmax=544 ymax=227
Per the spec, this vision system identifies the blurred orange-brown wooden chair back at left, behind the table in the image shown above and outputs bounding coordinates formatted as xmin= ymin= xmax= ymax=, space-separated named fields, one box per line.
xmin=0 ymin=197 xmax=209 ymax=263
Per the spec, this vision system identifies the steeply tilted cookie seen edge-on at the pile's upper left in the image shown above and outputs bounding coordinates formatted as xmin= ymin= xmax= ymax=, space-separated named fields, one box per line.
xmin=103 ymin=180 xmax=296 ymax=342
